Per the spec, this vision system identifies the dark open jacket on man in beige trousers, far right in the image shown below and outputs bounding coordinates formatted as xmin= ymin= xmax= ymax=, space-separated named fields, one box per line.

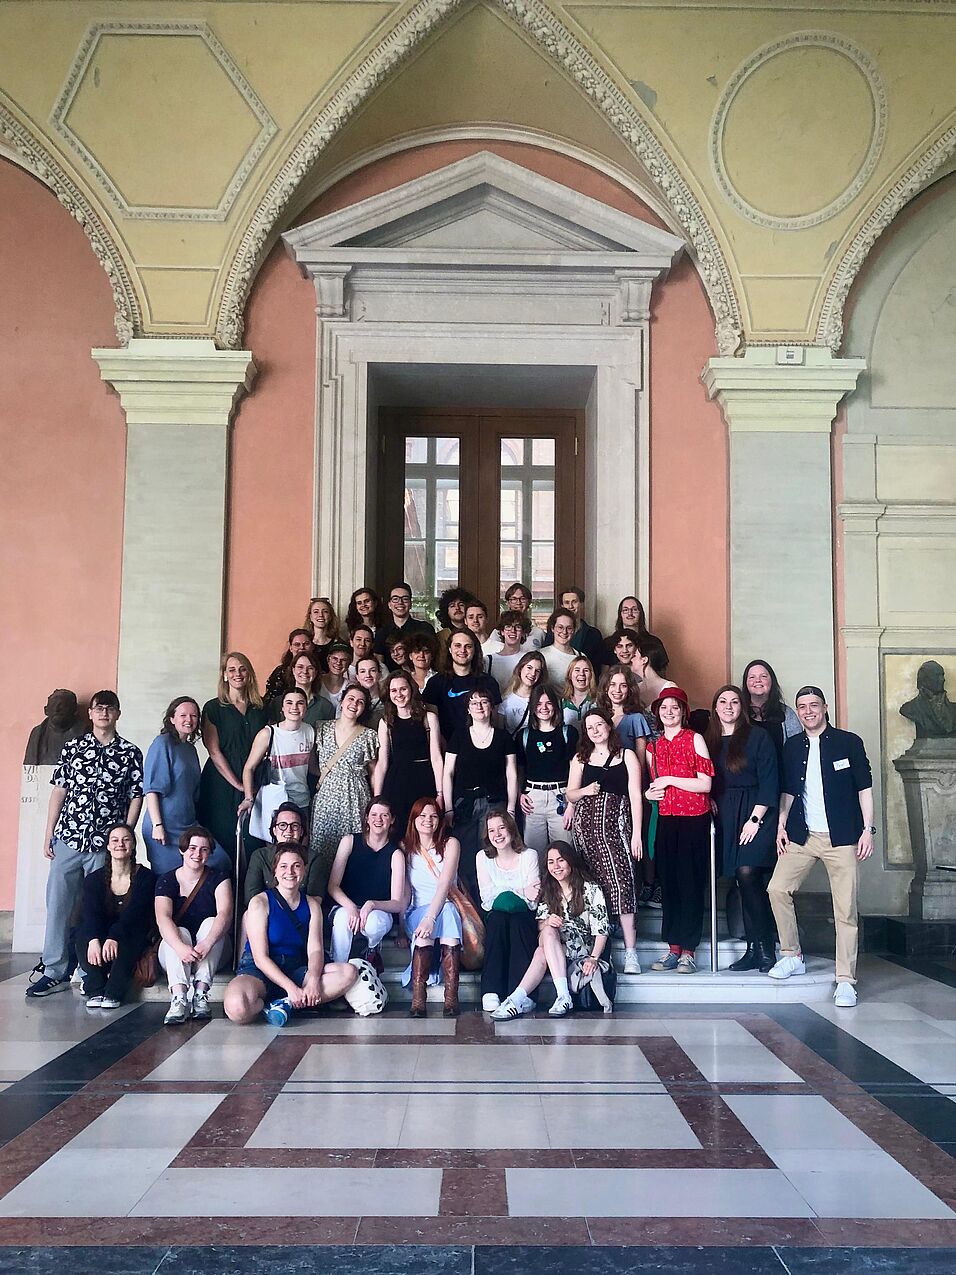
xmin=781 ymin=725 xmax=873 ymax=845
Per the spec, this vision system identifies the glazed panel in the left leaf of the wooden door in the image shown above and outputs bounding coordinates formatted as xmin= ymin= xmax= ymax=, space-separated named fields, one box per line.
xmin=403 ymin=435 xmax=460 ymax=620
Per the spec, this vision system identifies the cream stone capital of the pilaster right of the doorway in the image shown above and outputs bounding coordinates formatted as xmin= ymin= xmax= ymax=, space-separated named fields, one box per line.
xmin=701 ymin=346 xmax=867 ymax=434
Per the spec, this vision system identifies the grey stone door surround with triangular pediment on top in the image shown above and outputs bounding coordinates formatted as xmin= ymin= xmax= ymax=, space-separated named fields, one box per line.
xmin=283 ymin=152 xmax=683 ymax=624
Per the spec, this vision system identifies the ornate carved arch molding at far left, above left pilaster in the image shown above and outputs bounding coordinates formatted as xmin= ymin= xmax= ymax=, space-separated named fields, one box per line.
xmin=0 ymin=103 xmax=143 ymax=346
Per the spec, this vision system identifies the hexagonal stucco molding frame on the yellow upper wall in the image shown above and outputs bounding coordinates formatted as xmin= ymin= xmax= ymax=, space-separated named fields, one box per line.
xmin=50 ymin=22 xmax=278 ymax=222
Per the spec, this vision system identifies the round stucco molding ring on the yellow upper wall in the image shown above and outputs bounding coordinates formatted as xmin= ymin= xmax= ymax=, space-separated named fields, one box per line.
xmin=710 ymin=31 xmax=886 ymax=231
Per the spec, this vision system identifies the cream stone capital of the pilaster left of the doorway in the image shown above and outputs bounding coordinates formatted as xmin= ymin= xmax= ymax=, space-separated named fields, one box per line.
xmin=92 ymin=337 xmax=256 ymax=426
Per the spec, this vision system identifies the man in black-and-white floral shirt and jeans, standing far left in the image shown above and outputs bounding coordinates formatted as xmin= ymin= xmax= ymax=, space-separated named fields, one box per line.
xmin=27 ymin=691 xmax=143 ymax=998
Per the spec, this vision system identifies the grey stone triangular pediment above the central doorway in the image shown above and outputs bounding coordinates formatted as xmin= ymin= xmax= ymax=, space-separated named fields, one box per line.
xmin=283 ymin=152 xmax=683 ymax=270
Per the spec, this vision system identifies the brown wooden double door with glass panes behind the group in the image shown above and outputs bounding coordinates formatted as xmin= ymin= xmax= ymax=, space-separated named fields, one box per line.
xmin=377 ymin=408 xmax=584 ymax=623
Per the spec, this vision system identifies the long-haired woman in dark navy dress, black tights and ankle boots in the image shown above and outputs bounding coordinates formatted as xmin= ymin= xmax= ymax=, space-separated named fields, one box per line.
xmin=706 ymin=686 xmax=780 ymax=973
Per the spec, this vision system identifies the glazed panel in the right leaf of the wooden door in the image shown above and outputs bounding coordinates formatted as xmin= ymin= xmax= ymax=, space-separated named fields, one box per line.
xmin=498 ymin=439 xmax=556 ymax=618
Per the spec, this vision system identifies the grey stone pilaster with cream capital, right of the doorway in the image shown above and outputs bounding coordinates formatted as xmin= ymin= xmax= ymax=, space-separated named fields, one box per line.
xmin=701 ymin=347 xmax=865 ymax=704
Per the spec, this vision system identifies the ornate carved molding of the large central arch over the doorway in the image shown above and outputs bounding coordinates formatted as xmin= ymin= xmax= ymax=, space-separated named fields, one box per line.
xmin=217 ymin=0 xmax=742 ymax=354
